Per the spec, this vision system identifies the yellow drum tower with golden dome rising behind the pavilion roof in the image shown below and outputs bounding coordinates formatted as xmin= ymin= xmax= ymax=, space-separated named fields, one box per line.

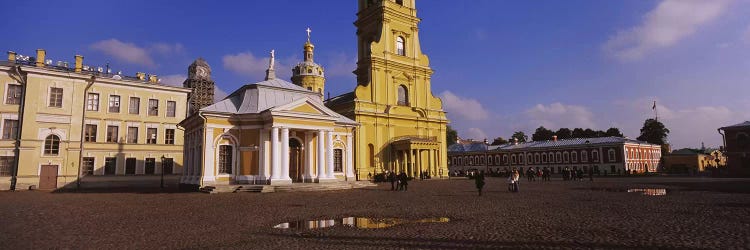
xmin=292 ymin=28 xmax=326 ymax=98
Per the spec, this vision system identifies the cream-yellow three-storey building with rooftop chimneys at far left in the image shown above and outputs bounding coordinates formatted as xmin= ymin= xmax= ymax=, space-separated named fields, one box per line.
xmin=0 ymin=50 xmax=190 ymax=189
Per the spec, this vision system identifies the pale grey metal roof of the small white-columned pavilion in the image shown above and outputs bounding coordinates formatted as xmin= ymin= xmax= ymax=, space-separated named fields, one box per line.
xmin=201 ymin=78 xmax=356 ymax=124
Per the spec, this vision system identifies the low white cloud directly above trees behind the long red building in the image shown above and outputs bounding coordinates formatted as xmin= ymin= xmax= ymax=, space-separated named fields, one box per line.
xmin=524 ymin=102 xmax=596 ymax=130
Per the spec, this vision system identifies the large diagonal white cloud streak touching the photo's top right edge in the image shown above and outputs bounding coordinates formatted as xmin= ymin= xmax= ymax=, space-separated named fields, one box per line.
xmin=603 ymin=0 xmax=732 ymax=61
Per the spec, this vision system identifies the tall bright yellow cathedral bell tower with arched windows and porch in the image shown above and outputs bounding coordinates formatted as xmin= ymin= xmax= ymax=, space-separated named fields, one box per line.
xmin=326 ymin=0 xmax=448 ymax=179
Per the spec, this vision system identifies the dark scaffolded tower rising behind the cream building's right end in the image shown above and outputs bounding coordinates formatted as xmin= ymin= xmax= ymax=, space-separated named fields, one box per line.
xmin=182 ymin=58 xmax=216 ymax=114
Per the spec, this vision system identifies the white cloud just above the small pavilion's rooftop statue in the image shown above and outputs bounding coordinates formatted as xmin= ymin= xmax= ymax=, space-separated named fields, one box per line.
xmin=221 ymin=52 xmax=292 ymax=81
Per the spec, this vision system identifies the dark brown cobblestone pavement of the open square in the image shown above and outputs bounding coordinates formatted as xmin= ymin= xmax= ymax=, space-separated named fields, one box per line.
xmin=0 ymin=177 xmax=750 ymax=249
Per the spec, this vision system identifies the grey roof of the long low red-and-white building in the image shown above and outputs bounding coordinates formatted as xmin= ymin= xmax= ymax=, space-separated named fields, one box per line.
xmin=448 ymin=136 xmax=656 ymax=152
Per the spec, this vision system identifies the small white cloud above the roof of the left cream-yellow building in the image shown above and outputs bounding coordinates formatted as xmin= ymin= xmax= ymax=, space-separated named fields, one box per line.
xmin=90 ymin=38 xmax=155 ymax=67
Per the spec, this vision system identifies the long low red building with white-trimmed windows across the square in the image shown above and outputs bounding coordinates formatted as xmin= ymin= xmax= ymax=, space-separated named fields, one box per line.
xmin=448 ymin=137 xmax=661 ymax=174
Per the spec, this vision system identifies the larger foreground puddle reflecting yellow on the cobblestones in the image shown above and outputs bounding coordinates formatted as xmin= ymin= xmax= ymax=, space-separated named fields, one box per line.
xmin=273 ymin=217 xmax=450 ymax=229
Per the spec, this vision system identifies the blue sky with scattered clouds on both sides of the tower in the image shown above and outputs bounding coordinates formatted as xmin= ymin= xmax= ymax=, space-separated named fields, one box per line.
xmin=0 ymin=0 xmax=750 ymax=148
